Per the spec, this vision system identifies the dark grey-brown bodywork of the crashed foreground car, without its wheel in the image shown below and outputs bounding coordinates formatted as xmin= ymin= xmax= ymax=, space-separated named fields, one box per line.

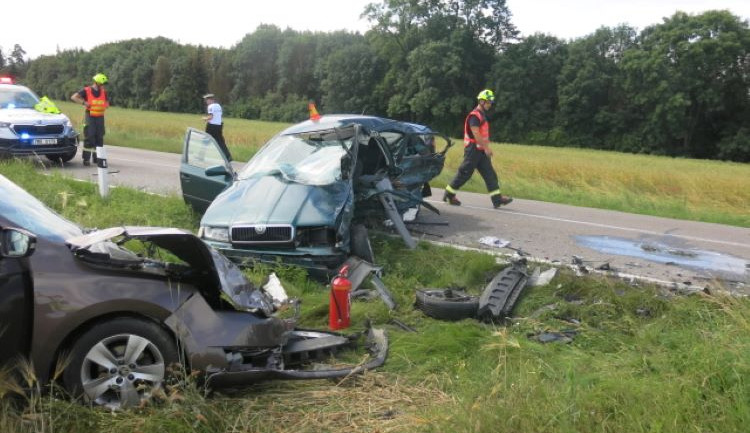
xmin=0 ymin=175 xmax=387 ymax=406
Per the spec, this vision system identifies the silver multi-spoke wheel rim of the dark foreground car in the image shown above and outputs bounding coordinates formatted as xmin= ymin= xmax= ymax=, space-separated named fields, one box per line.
xmin=81 ymin=334 xmax=166 ymax=409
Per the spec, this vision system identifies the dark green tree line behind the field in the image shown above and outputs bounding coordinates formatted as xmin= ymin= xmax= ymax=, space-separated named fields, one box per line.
xmin=0 ymin=0 xmax=750 ymax=162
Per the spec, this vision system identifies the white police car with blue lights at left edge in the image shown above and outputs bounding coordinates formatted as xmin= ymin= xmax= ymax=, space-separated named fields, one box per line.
xmin=0 ymin=77 xmax=78 ymax=162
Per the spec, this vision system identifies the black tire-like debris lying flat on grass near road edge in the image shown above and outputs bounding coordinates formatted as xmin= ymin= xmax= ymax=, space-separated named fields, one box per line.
xmin=414 ymin=289 xmax=479 ymax=320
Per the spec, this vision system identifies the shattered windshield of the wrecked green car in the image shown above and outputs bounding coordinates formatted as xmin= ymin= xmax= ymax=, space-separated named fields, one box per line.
xmin=239 ymin=128 xmax=356 ymax=185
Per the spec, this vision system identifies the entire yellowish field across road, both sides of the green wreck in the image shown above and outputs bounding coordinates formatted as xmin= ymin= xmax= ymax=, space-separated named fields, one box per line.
xmin=58 ymin=98 xmax=750 ymax=227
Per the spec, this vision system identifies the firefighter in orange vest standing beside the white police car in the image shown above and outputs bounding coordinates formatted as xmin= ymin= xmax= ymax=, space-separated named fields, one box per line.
xmin=70 ymin=73 xmax=109 ymax=165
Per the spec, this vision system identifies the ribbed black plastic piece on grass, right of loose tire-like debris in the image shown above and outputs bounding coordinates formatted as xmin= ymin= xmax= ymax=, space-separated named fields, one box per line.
xmin=477 ymin=261 xmax=529 ymax=321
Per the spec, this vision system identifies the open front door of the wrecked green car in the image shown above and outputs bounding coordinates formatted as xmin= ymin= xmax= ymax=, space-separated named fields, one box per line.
xmin=180 ymin=128 xmax=236 ymax=213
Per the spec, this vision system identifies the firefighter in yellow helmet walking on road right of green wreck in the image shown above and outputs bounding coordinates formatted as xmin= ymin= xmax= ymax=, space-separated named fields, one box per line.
xmin=443 ymin=89 xmax=513 ymax=209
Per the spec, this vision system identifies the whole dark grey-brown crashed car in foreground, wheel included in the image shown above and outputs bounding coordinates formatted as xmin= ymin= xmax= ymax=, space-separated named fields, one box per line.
xmin=0 ymin=175 xmax=388 ymax=408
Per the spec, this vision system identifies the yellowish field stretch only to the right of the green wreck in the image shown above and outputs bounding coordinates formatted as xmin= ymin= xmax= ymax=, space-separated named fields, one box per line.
xmin=433 ymin=144 xmax=750 ymax=227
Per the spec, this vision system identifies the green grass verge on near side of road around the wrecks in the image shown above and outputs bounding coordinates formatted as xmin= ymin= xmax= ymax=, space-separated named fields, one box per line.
xmin=0 ymin=162 xmax=750 ymax=433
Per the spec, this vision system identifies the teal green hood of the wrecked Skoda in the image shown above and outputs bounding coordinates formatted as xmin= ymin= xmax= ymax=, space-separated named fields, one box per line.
xmin=201 ymin=175 xmax=351 ymax=227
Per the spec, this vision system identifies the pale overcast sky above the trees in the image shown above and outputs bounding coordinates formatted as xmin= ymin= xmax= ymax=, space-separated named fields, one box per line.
xmin=0 ymin=0 xmax=750 ymax=58
